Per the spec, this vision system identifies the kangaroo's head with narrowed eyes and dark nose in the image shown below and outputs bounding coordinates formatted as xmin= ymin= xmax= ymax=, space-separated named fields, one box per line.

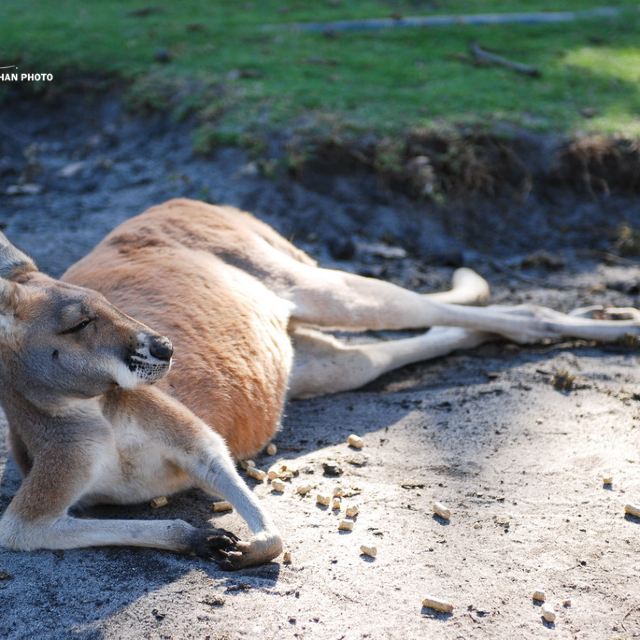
xmin=0 ymin=233 xmax=173 ymax=400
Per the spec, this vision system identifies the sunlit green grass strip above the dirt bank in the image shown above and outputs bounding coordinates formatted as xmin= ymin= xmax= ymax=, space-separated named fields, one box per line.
xmin=0 ymin=0 xmax=640 ymax=140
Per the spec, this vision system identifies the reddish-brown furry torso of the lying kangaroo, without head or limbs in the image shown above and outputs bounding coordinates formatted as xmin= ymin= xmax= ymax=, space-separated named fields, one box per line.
xmin=63 ymin=200 xmax=296 ymax=458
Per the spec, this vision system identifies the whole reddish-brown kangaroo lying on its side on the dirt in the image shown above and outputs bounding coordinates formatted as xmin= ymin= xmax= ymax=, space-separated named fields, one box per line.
xmin=0 ymin=200 xmax=640 ymax=569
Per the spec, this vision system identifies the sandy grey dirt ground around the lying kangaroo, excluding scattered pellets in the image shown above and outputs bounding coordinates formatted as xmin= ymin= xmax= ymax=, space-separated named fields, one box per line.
xmin=0 ymin=98 xmax=640 ymax=640
